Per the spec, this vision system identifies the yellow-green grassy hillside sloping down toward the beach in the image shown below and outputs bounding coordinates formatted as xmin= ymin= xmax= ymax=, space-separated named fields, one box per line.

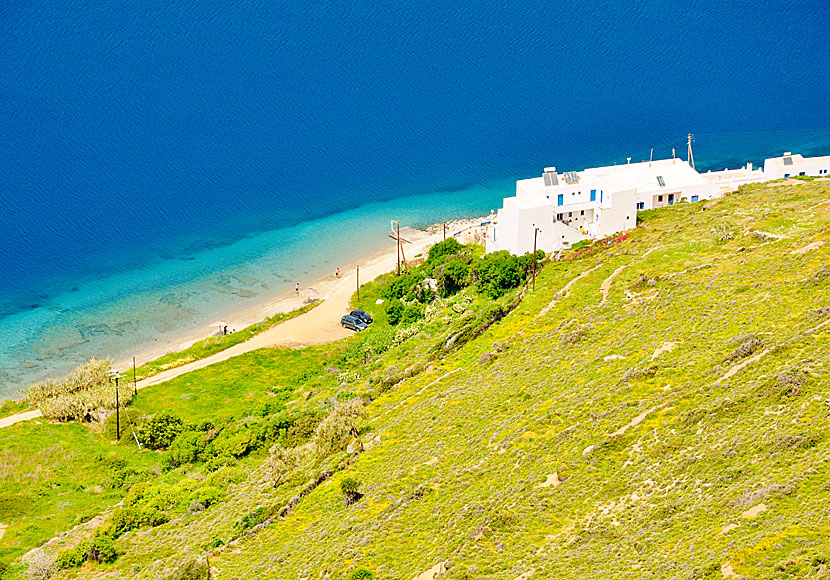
xmin=0 ymin=180 xmax=830 ymax=580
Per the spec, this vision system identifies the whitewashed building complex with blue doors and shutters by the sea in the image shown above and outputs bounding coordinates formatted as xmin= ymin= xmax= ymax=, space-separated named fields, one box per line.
xmin=487 ymin=153 xmax=830 ymax=254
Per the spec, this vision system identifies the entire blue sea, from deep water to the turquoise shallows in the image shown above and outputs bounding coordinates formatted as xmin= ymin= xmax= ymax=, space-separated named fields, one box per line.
xmin=0 ymin=0 xmax=830 ymax=399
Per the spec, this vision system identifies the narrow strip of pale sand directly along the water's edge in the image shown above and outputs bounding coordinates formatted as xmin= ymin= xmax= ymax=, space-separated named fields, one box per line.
xmin=113 ymin=216 xmax=489 ymax=384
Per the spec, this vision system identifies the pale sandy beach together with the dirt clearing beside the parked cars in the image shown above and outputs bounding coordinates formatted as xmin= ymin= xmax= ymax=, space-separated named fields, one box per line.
xmin=115 ymin=218 xmax=488 ymax=388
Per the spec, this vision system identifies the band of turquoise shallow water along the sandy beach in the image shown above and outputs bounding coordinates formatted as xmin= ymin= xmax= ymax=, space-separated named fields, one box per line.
xmin=0 ymin=182 xmax=512 ymax=397
